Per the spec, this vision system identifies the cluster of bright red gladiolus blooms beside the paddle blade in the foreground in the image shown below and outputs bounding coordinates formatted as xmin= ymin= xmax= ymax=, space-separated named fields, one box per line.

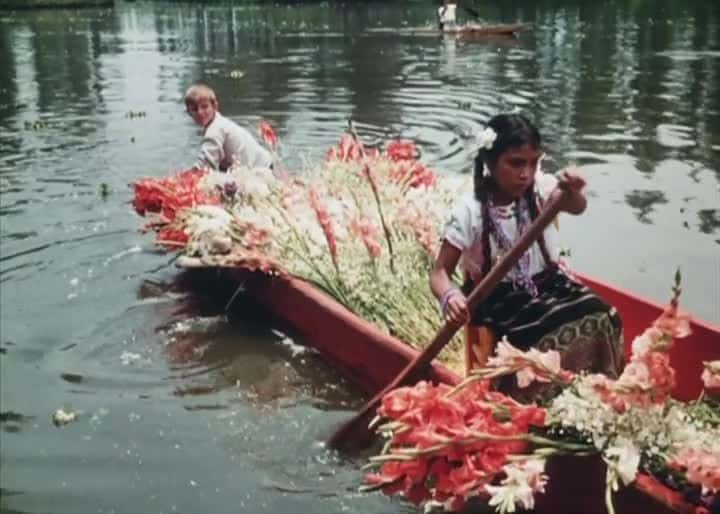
xmin=367 ymin=379 xmax=545 ymax=509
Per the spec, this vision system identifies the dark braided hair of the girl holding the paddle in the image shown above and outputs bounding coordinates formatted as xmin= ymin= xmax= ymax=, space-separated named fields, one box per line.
xmin=473 ymin=114 xmax=541 ymax=202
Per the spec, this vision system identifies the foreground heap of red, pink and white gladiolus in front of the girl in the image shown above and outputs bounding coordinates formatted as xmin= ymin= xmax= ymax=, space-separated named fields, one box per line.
xmin=363 ymin=276 xmax=720 ymax=513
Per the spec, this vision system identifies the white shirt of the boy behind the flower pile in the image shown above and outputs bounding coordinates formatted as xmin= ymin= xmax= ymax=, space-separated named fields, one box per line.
xmin=196 ymin=112 xmax=272 ymax=171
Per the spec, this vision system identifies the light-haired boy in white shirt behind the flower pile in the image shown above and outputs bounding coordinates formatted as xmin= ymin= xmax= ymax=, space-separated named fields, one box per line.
xmin=185 ymin=84 xmax=273 ymax=171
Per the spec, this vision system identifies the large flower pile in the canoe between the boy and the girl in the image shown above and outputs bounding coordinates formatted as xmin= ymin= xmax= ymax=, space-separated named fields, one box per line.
xmin=133 ymin=123 xmax=468 ymax=369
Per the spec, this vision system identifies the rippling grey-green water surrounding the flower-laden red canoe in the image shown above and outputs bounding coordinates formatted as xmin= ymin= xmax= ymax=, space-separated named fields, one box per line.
xmin=0 ymin=0 xmax=720 ymax=512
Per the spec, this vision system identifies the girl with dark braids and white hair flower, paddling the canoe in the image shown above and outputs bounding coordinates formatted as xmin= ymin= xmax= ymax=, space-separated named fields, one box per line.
xmin=430 ymin=114 xmax=623 ymax=377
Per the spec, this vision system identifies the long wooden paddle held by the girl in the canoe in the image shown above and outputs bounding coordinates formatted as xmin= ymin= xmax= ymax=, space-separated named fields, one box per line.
xmin=329 ymin=184 xmax=567 ymax=450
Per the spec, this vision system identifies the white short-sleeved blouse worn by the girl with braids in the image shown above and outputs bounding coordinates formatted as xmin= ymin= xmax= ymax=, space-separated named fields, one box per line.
xmin=443 ymin=172 xmax=560 ymax=282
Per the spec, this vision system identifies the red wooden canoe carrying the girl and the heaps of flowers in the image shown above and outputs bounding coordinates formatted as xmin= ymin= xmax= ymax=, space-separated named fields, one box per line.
xmin=182 ymin=260 xmax=720 ymax=514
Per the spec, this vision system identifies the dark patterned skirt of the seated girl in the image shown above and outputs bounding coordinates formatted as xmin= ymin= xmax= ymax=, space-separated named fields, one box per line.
xmin=463 ymin=267 xmax=624 ymax=377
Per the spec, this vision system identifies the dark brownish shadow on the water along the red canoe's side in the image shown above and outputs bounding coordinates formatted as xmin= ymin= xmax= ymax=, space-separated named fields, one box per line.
xmin=158 ymin=271 xmax=362 ymax=409
